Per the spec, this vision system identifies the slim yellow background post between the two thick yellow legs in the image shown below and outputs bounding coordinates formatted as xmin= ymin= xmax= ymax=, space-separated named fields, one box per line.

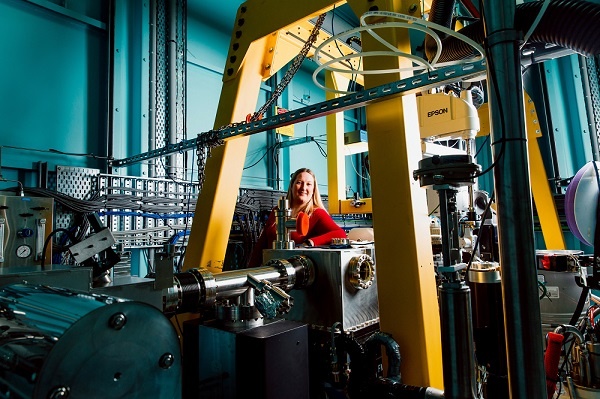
xmin=325 ymin=71 xmax=348 ymax=214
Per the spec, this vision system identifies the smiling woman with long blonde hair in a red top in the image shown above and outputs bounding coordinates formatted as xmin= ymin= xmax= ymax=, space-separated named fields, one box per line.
xmin=248 ymin=168 xmax=346 ymax=267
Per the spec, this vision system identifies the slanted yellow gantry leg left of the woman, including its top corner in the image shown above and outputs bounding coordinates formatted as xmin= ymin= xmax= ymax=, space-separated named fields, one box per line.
xmin=183 ymin=0 xmax=370 ymax=273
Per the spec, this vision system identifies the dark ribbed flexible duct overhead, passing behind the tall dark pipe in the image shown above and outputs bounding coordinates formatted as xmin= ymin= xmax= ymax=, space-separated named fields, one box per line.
xmin=425 ymin=0 xmax=600 ymax=62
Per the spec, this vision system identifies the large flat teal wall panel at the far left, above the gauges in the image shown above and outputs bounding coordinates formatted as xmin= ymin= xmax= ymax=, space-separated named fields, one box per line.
xmin=0 ymin=0 xmax=107 ymax=188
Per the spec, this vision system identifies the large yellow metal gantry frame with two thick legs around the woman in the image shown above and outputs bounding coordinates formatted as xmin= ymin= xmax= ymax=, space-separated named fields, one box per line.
xmin=184 ymin=0 xmax=443 ymax=389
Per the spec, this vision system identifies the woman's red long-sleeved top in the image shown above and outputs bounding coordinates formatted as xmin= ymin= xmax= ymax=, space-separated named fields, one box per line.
xmin=248 ymin=208 xmax=347 ymax=267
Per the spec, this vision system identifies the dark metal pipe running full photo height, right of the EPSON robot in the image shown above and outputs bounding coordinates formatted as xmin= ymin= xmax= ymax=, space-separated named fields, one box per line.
xmin=482 ymin=0 xmax=546 ymax=398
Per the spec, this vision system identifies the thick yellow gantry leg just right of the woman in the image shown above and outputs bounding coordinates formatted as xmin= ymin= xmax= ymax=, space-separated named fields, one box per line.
xmin=348 ymin=0 xmax=443 ymax=389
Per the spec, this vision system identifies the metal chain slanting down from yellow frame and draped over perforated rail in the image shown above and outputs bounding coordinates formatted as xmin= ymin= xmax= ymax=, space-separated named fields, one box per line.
xmin=196 ymin=14 xmax=325 ymax=194
